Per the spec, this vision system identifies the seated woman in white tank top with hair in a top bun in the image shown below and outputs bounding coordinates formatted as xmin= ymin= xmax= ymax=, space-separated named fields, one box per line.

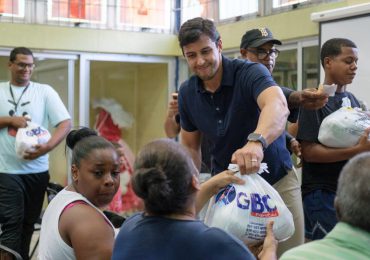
xmin=39 ymin=128 xmax=120 ymax=260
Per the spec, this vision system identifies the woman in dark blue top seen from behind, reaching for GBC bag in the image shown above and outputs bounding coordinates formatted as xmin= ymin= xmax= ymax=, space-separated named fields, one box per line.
xmin=112 ymin=139 xmax=277 ymax=260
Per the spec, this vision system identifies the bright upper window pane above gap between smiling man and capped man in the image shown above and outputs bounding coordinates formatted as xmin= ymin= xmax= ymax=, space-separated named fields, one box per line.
xmin=219 ymin=0 xmax=258 ymax=20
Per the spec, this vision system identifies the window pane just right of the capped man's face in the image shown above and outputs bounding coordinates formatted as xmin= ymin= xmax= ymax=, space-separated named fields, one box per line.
xmin=272 ymin=50 xmax=297 ymax=90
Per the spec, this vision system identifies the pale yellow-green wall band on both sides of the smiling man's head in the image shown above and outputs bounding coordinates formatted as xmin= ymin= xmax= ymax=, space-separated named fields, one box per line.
xmin=0 ymin=0 xmax=369 ymax=56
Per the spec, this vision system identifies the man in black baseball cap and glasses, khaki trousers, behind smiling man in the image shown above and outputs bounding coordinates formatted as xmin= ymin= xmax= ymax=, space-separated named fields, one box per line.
xmin=240 ymin=28 xmax=327 ymax=256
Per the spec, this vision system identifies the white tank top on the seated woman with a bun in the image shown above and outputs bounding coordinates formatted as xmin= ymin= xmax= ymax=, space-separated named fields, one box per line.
xmin=38 ymin=189 xmax=118 ymax=260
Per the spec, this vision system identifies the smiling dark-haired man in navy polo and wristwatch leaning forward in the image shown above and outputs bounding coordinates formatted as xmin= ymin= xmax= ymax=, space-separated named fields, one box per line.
xmin=179 ymin=18 xmax=294 ymax=256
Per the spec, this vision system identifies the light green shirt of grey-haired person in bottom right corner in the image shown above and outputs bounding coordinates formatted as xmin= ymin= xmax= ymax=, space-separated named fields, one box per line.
xmin=280 ymin=222 xmax=370 ymax=260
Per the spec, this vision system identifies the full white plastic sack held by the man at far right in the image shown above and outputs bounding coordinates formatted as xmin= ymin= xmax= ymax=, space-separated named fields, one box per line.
xmin=318 ymin=107 xmax=370 ymax=148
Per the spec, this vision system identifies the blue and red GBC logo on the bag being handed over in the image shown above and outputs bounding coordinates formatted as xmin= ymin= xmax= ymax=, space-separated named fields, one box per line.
xmin=215 ymin=185 xmax=279 ymax=218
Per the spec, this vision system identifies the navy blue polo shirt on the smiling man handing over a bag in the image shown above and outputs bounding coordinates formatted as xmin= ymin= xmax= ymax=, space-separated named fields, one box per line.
xmin=179 ymin=57 xmax=292 ymax=184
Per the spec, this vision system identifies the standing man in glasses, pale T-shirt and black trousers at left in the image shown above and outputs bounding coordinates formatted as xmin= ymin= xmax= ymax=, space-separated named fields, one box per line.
xmin=0 ymin=47 xmax=71 ymax=259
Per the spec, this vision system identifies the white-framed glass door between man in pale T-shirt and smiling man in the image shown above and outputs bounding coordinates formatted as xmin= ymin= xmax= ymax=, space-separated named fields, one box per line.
xmin=79 ymin=54 xmax=176 ymax=154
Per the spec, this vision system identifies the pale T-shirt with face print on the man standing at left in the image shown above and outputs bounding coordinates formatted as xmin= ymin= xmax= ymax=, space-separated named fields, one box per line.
xmin=0 ymin=82 xmax=70 ymax=174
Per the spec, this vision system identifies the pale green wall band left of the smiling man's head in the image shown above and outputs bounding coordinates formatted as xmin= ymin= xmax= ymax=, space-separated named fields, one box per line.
xmin=0 ymin=23 xmax=179 ymax=56
